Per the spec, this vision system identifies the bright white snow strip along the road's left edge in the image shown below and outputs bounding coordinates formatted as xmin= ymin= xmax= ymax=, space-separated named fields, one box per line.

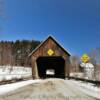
xmin=0 ymin=80 xmax=41 ymax=95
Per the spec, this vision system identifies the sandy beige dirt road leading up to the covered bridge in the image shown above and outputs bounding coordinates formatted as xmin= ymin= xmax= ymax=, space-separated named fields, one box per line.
xmin=0 ymin=79 xmax=99 ymax=100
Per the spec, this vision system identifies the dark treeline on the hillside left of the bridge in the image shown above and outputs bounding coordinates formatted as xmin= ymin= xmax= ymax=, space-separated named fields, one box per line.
xmin=0 ymin=40 xmax=40 ymax=66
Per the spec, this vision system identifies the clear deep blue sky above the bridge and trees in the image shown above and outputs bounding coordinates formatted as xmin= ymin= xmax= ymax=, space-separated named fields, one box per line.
xmin=0 ymin=0 xmax=100 ymax=55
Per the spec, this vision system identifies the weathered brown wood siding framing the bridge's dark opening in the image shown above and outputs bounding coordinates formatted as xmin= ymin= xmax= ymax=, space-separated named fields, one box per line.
xmin=31 ymin=38 xmax=69 ymax=78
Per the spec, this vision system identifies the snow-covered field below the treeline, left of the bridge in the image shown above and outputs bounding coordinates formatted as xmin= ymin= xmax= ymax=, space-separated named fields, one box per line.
xmin=0 ymin=66 xmax=32 ymax=81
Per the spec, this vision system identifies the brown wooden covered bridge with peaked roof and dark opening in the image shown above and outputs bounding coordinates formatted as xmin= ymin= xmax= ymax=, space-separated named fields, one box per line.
xmin=29 ymin=36 xmax=70 ymax=78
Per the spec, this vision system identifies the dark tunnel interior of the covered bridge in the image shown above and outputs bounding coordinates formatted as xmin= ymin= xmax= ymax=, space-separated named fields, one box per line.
xmin=36 ymin=56 xmax=65 ymax=79
